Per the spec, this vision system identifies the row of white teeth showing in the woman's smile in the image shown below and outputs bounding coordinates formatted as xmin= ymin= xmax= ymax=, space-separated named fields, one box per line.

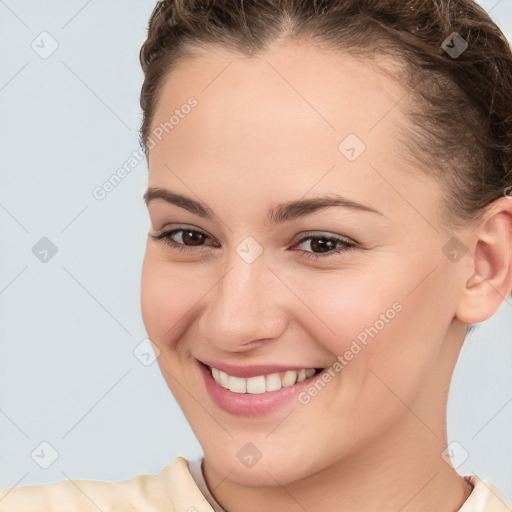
xmin=211 ymin=368 xmax=316 ymax=395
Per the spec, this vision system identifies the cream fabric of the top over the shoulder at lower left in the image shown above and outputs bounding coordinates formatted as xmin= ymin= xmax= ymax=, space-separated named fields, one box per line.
xmin=0 ymin=457 xmax=199 ymax=512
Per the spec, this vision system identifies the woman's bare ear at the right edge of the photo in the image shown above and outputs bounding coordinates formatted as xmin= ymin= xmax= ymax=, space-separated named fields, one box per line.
xmin=455 ymin=196 xmax=512 ymax=324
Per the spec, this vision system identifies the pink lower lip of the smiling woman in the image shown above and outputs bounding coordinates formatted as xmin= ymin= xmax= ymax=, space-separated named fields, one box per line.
xmin=199 ymin=363 xmax=318 ymax=417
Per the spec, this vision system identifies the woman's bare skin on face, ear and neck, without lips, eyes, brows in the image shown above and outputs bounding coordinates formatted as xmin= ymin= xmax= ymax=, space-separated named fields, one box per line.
xmin=142 ymin=43 xmax=512 ymax=512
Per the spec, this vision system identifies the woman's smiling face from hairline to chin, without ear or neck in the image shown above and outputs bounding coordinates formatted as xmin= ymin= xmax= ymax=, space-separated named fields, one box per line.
xmin=142 ymin=44 xmax=467 ymax=486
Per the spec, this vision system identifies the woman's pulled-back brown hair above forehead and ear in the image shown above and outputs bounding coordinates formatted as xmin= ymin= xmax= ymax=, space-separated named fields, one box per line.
xmin=140 ymin=0 xmax=512 ymax=226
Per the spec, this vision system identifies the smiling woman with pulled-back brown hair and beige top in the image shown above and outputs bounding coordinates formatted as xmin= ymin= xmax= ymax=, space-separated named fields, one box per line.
xmin=0 ymin=0 xmax=512 ymax=512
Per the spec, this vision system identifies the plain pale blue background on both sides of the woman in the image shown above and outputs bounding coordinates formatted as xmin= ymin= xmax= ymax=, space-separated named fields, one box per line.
xmin=0 ymin=0 xmax=512 ymax=499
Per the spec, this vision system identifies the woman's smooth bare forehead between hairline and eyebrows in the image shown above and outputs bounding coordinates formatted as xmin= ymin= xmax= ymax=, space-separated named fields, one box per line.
xmin=149 ymin=44 xmax=438 ymax=227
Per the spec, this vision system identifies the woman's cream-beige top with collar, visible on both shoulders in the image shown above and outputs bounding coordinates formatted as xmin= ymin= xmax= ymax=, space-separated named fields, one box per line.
xmin=0 ymin=457 xmax=512 ymax=512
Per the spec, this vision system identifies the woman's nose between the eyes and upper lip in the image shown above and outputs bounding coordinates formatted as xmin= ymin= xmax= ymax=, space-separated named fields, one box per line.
xmin=199 ymin=251 xmax=289 ymax=352
